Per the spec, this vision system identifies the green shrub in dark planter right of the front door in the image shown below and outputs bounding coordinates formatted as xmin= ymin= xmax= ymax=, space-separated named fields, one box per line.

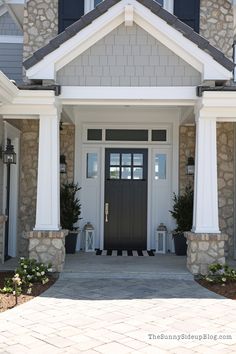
xmin=170 ymin=186 xmax=193 ymax=256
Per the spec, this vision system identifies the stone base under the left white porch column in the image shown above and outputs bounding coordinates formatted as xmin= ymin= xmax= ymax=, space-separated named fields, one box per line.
xmin=27 ymin=230 xmax=68 ymax=272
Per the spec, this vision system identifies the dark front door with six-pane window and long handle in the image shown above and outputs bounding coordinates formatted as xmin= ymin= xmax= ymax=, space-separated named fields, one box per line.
xmin=104 ymin=149 xmax=148 ymax=250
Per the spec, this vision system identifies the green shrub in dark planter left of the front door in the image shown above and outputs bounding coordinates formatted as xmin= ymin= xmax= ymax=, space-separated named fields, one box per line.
xmin=60 ymin=182 xmax=81 ymax=253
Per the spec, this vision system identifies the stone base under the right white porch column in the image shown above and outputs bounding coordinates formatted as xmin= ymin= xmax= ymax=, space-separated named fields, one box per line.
xmin=185 ymin=232 xmax=228 ymax=275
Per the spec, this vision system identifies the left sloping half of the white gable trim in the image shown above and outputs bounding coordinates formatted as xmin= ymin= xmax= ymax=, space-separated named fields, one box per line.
xmin=26 ymin=1 xmax=124 ymax=80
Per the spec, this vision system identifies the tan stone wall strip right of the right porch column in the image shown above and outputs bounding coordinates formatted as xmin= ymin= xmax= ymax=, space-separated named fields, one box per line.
xmin=217 ymin=123 xmax=235 ymax=257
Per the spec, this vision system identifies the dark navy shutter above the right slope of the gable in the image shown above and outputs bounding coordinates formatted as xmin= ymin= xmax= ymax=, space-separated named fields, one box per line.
xmin=174 ymin=0 xmax=200 ymax=32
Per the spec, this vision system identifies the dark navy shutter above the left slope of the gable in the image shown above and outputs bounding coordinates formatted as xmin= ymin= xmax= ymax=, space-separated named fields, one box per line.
xmin=58 ymin=0 xmax=84 ymax=33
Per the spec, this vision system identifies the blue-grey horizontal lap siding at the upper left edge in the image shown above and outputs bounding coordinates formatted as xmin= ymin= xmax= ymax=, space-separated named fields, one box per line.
xmin=0 ymin=43 xmax=23 ymax=83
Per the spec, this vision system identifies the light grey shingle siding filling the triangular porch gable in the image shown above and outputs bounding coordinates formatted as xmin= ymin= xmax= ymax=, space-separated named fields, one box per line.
xmin=57 ymin=25 xmax=201 ymax=86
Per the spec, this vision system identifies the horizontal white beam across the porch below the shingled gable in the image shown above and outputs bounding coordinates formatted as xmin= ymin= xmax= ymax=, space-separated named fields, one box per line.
xmin=60 ymin=86 xmax=198 ymax=105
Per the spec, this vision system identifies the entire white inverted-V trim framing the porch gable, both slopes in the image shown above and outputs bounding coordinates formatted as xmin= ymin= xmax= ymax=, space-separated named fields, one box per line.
xmin=26 ymin=0 xmax=232 ymax=80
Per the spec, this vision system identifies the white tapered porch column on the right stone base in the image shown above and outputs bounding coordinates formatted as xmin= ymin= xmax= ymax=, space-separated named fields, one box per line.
xmin=192 ymin=110 xmax=220 ymax=234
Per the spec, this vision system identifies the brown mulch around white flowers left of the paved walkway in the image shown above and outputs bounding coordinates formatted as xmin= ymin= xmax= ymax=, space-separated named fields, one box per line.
xmin=0 ymin=272 xmax=58 ymax=312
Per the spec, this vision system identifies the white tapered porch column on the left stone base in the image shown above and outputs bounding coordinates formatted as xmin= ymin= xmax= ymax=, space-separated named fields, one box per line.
xmin=34 ymin=113 xmax=60 ymax=231
